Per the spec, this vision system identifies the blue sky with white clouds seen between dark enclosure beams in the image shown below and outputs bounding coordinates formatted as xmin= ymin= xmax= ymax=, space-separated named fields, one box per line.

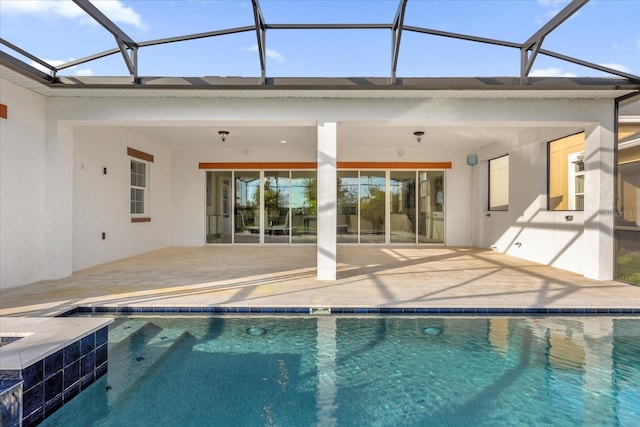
xmin=0 ymin=0 xmax=640 ymax=77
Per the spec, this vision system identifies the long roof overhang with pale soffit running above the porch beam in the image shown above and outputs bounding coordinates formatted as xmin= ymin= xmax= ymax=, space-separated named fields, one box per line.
xmin=0 ymin=63 xmax=640 ymax=99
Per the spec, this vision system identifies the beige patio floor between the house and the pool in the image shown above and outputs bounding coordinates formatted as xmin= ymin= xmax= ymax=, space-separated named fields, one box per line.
xmin=0 ymin=246 xmax=640 ymax=316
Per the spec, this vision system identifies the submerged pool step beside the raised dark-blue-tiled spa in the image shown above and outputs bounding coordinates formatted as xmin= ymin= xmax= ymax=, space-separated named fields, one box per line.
xmin=106 ymin=322 xmax=190 ymax=405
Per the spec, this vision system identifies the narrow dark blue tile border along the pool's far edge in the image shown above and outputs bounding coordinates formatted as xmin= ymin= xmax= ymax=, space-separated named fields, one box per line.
xmin=59 ymin=306 xmax=640 ymax=317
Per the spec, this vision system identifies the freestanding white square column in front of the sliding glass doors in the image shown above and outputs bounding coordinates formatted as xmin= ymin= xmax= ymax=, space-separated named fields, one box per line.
xmin=316 ymin=122 xmax=337 ymax=280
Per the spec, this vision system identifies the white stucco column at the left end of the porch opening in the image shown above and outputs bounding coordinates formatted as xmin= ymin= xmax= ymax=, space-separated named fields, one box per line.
xmin=46 ymin=121 xmax=74 ymax=279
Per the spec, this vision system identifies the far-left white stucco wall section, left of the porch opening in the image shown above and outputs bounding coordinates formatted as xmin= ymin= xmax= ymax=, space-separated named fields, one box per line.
xmin=0 ymin=79 xmax=50 ymax=289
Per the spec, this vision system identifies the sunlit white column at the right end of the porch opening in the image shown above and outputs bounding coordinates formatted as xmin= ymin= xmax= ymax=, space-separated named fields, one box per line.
xmin=583 ymin=122 xmax=615 ymax=280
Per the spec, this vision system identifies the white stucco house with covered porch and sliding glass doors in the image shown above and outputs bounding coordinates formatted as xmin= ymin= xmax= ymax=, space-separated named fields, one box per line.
xmin=0 ymin=2 xmax=640 ymax=288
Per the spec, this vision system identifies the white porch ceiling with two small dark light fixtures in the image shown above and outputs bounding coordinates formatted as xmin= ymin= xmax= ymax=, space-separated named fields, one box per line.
xmin=115 ymin=122 xmax=583 ymax=153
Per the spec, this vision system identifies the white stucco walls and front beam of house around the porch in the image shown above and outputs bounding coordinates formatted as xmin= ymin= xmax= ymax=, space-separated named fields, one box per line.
xmin=0 ymin=81 xmax=613 ymax=287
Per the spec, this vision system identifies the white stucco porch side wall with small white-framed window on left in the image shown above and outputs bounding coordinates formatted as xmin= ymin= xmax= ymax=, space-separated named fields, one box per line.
xmin=73 ymin=126 xmax=173 ymax=271
